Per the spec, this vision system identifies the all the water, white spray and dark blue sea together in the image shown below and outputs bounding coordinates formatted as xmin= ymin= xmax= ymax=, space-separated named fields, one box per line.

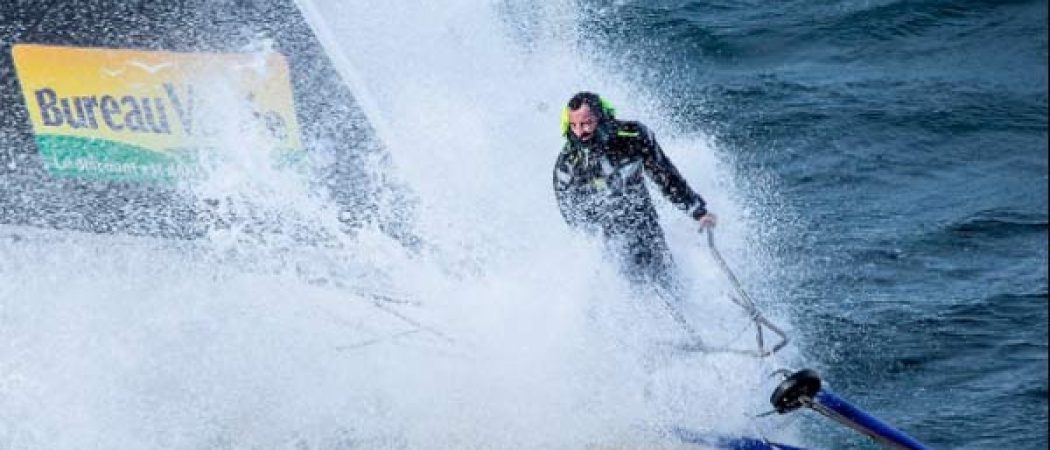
xmin=0 ymin=0 xmax=1048 ymax=449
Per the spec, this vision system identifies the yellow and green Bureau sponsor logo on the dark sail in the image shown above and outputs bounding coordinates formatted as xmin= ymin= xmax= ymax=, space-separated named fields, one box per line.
xmin=12 ymin=44 xmax=301 ymax=180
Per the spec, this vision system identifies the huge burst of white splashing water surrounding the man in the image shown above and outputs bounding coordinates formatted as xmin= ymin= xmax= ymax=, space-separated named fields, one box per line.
xmin=0 ymin=0 xmax=792 ymax=448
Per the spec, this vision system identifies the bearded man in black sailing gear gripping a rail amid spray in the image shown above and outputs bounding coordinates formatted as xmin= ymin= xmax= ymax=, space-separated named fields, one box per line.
xmin=554 ymin=92 xmax=715 ymax=294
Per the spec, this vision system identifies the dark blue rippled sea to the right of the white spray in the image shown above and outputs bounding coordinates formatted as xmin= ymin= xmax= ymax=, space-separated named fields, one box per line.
xmin=587 ymin=0 xmax=1048 ymax=449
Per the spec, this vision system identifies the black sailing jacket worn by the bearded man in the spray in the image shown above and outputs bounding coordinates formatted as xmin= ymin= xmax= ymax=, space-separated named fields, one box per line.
xmin=554 ymin=120 xmax=707 ymax=241
